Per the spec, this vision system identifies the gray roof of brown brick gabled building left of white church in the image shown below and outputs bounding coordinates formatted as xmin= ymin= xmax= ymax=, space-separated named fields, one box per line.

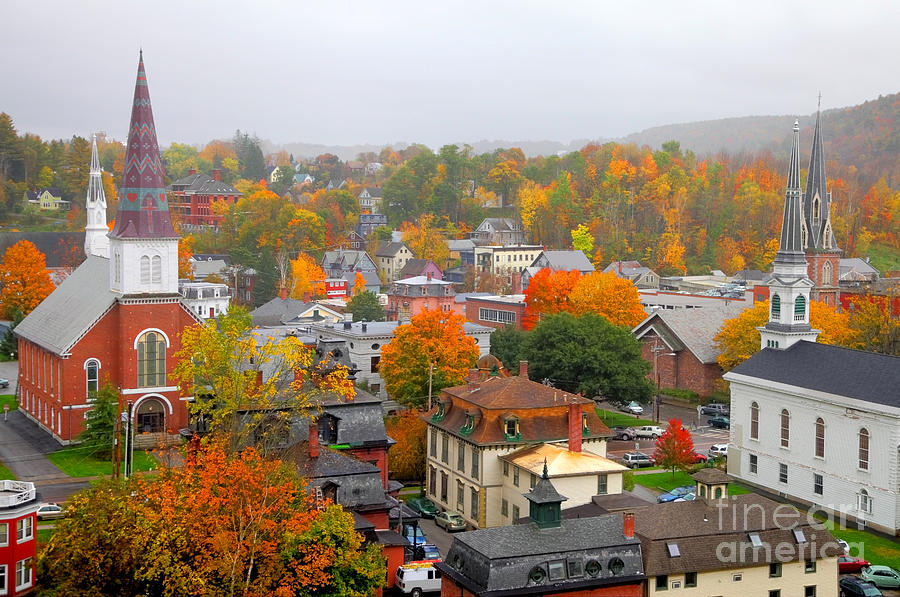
xmin=634 ymin=303 xmax=745 ymax=364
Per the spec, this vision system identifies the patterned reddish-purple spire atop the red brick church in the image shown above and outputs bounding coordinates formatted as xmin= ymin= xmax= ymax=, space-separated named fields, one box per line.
xmin=110 ymin=52 xmax=178 ymax=238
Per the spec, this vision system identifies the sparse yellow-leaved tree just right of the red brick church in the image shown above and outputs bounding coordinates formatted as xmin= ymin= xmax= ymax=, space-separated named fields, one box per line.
xmin=174 ymin=306 xmax=354 ymax=451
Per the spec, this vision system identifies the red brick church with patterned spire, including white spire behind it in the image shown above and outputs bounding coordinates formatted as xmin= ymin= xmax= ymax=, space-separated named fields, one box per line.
xmin=15 ymin=52 xmax=198 ymax=443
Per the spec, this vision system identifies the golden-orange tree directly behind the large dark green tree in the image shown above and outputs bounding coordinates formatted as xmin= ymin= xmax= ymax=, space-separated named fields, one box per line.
xmin=569 ymin=272 xmax=647 ymax=328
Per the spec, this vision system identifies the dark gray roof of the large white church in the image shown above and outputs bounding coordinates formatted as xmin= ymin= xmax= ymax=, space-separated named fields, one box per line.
xmin=725 ymin=341 xmax=900 ymax=408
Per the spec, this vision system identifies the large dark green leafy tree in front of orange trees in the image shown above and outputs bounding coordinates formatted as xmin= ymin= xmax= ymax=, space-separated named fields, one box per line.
xmin=521 ymin=313 xmax=653 ymax=403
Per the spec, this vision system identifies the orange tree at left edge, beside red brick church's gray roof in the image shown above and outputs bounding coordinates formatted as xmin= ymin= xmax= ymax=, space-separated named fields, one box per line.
xmin=0 ymin=240 xmax=53 ymax=319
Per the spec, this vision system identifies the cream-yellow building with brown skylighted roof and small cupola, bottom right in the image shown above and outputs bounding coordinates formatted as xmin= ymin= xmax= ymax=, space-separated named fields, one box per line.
xmin=634 ymin=468 xmax=843 ymax=597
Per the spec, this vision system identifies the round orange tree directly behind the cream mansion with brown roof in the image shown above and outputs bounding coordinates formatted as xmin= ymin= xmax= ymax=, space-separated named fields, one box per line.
xmin=379 ymin=309 xmax=479 ymax=407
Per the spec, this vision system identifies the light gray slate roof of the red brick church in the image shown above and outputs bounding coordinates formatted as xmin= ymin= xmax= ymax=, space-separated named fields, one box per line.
xmin=15 ymin=255 xmax=116 ymax=355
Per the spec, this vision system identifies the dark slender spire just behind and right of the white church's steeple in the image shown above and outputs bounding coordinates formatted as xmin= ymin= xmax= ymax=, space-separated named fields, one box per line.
xmin=803 ymin=108 xmax=838 ymax=251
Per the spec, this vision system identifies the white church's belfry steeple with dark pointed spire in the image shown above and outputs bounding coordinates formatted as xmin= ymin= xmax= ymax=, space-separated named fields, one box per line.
xmin=757 ymin=121 xmax=819 ymax=349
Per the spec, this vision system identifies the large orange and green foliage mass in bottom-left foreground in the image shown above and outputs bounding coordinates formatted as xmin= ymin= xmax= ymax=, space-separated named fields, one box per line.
xmin=38 ymin=443 xmax=385 ymax=597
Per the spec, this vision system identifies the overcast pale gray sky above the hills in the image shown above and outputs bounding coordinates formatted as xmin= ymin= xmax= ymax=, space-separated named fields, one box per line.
xmin=0 ymin=0 xmax=900 ymax=147
